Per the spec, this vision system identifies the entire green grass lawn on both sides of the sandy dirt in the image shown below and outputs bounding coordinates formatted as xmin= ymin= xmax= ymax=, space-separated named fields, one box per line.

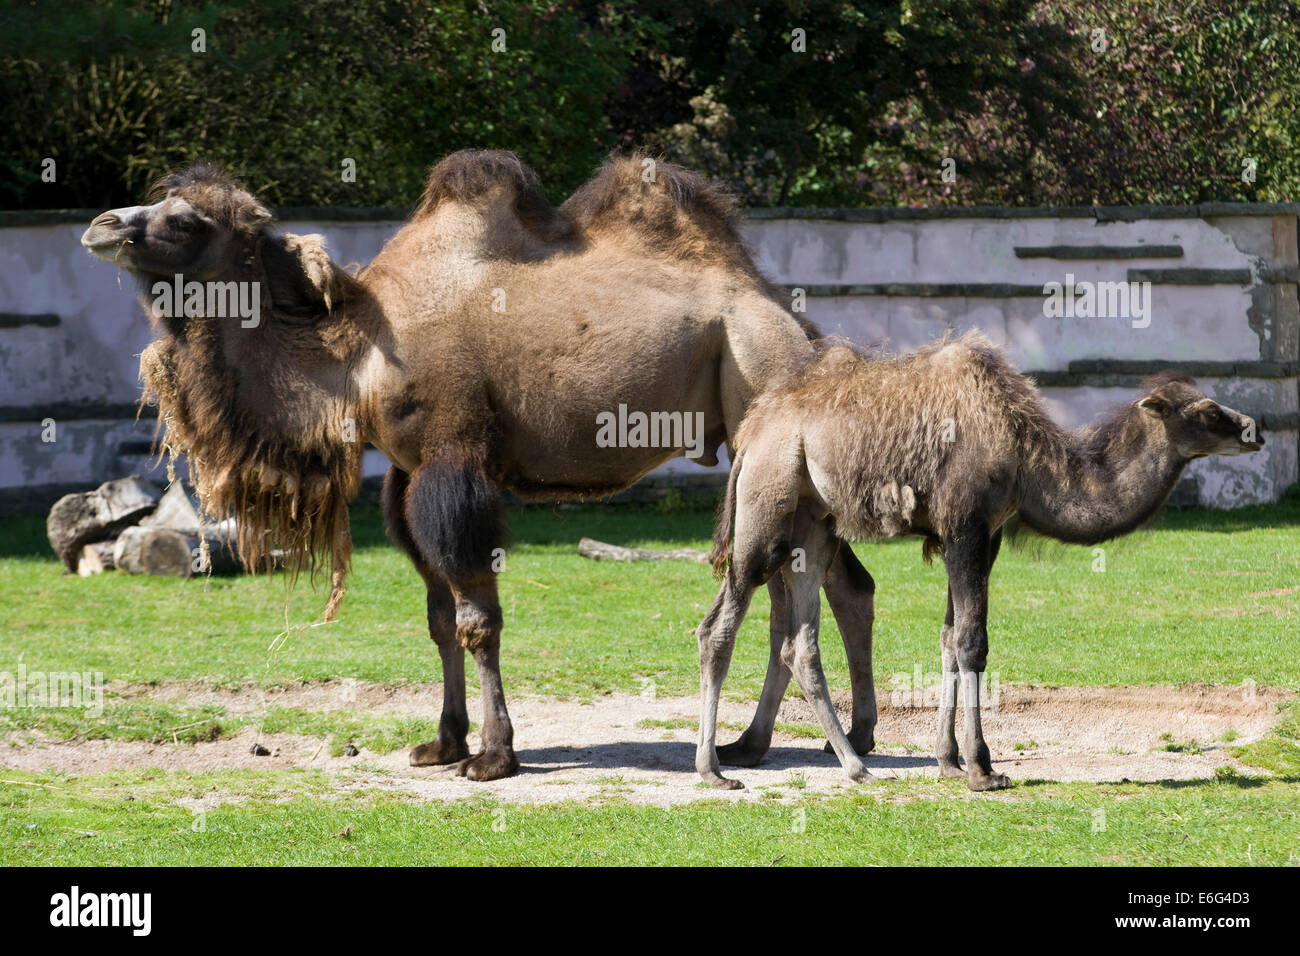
xmin=0 ymin=493 xmax=1300 ymax=864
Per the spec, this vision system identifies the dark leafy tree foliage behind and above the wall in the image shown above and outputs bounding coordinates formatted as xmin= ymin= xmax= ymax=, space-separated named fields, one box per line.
xmin=0 ymin=0 xmax=1300 ymax=208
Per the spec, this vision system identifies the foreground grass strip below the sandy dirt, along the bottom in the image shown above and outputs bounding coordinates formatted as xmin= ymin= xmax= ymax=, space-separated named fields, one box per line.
xmin=0 ymin=771 xmax=1300 ymax=866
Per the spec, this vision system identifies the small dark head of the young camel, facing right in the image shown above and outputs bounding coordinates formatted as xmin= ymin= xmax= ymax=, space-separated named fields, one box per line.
xmin=1135 ymin=373 xmax=1264 ymax=459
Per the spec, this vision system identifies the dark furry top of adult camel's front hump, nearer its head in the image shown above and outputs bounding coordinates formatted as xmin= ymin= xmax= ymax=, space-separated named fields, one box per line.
xmin=415 ymin=150 xmax=572 ymax=239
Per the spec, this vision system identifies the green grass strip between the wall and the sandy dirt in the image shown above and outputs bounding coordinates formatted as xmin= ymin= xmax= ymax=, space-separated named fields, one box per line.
xmin=0 ymin=496 xmax=1300 ymax=698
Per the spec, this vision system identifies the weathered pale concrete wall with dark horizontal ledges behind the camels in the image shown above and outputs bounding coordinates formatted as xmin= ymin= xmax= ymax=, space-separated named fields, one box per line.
xmin=0 ymin=206 xmax=1300 ymax=507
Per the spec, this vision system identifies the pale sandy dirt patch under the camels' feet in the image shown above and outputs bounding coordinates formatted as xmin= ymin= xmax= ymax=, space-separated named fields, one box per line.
xmin=0 ymin=682 xmax=1288 ymax=805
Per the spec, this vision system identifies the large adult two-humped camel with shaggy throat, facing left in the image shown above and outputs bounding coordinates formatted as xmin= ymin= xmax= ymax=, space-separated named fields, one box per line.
xmin=82 ymin=151 xmax=876 ymax=780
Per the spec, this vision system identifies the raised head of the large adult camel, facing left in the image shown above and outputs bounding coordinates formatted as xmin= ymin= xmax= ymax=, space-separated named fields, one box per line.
xmin=82 ymin=163 xmax=270 ymax=282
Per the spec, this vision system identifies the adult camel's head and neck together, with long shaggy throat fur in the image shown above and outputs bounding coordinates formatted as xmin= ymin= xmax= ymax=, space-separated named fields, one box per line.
xmin=82 ymin=164 xmax=361 ymax=617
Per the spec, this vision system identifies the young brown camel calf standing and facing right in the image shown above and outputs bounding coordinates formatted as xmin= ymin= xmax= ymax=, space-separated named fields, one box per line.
xmin=696 ymin=333 xmax=1264 ymax=791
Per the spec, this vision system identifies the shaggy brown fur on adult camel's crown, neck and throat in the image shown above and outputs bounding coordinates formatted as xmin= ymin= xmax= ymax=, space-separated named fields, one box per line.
xmin=122 ymin=164 xmax=361 ymax=619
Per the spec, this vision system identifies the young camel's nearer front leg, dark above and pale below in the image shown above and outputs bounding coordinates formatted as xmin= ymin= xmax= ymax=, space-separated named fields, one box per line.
xmin=944 ymin=519 xmax=1011 ymax=791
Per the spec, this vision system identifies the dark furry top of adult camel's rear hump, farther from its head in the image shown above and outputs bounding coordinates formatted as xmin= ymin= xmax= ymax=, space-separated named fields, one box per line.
xmin=560 ymin=156 xmax=753 ymax=272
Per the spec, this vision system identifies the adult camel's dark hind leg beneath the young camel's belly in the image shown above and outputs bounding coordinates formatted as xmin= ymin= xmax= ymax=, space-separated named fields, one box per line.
xmin=823 ymin=541 xmax=878 ymax=757
